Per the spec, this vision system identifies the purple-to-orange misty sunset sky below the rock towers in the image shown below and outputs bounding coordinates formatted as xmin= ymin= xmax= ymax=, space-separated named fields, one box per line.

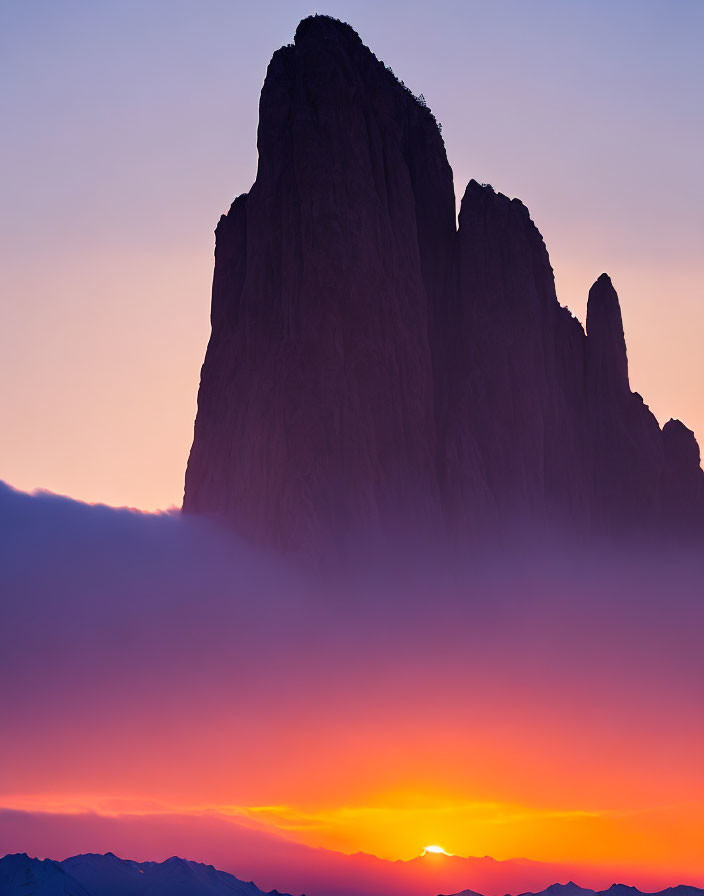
xmin=0 ymin=486 xmax=704 ymax=896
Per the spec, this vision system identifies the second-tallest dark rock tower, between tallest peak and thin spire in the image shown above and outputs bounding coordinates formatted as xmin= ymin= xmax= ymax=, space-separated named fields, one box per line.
xmin=447 ymin=181 xmax=590 ymax=517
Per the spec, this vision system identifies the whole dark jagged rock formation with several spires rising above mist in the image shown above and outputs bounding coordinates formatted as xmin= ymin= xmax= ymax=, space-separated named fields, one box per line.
xmin=184 ymin=16 xmax=704 ymax=550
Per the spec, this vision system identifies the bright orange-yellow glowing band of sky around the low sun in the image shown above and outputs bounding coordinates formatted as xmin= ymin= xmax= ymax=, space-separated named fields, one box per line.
xmin=0 ymin=793 xmax=704 ymax=881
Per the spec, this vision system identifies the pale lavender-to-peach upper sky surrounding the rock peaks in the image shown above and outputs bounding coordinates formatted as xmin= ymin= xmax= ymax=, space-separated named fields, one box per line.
xmin=0 ymin=0 xmax=704 ymax=510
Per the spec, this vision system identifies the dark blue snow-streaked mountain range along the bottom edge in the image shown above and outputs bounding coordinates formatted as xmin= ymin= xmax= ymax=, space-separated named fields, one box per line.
xmin=0 ymin=852 xmax=704 ymax=896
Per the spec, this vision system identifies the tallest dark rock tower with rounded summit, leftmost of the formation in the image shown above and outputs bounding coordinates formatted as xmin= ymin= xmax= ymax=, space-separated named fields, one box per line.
xmin=184 ymin=17 xmax=454 ymax=545
